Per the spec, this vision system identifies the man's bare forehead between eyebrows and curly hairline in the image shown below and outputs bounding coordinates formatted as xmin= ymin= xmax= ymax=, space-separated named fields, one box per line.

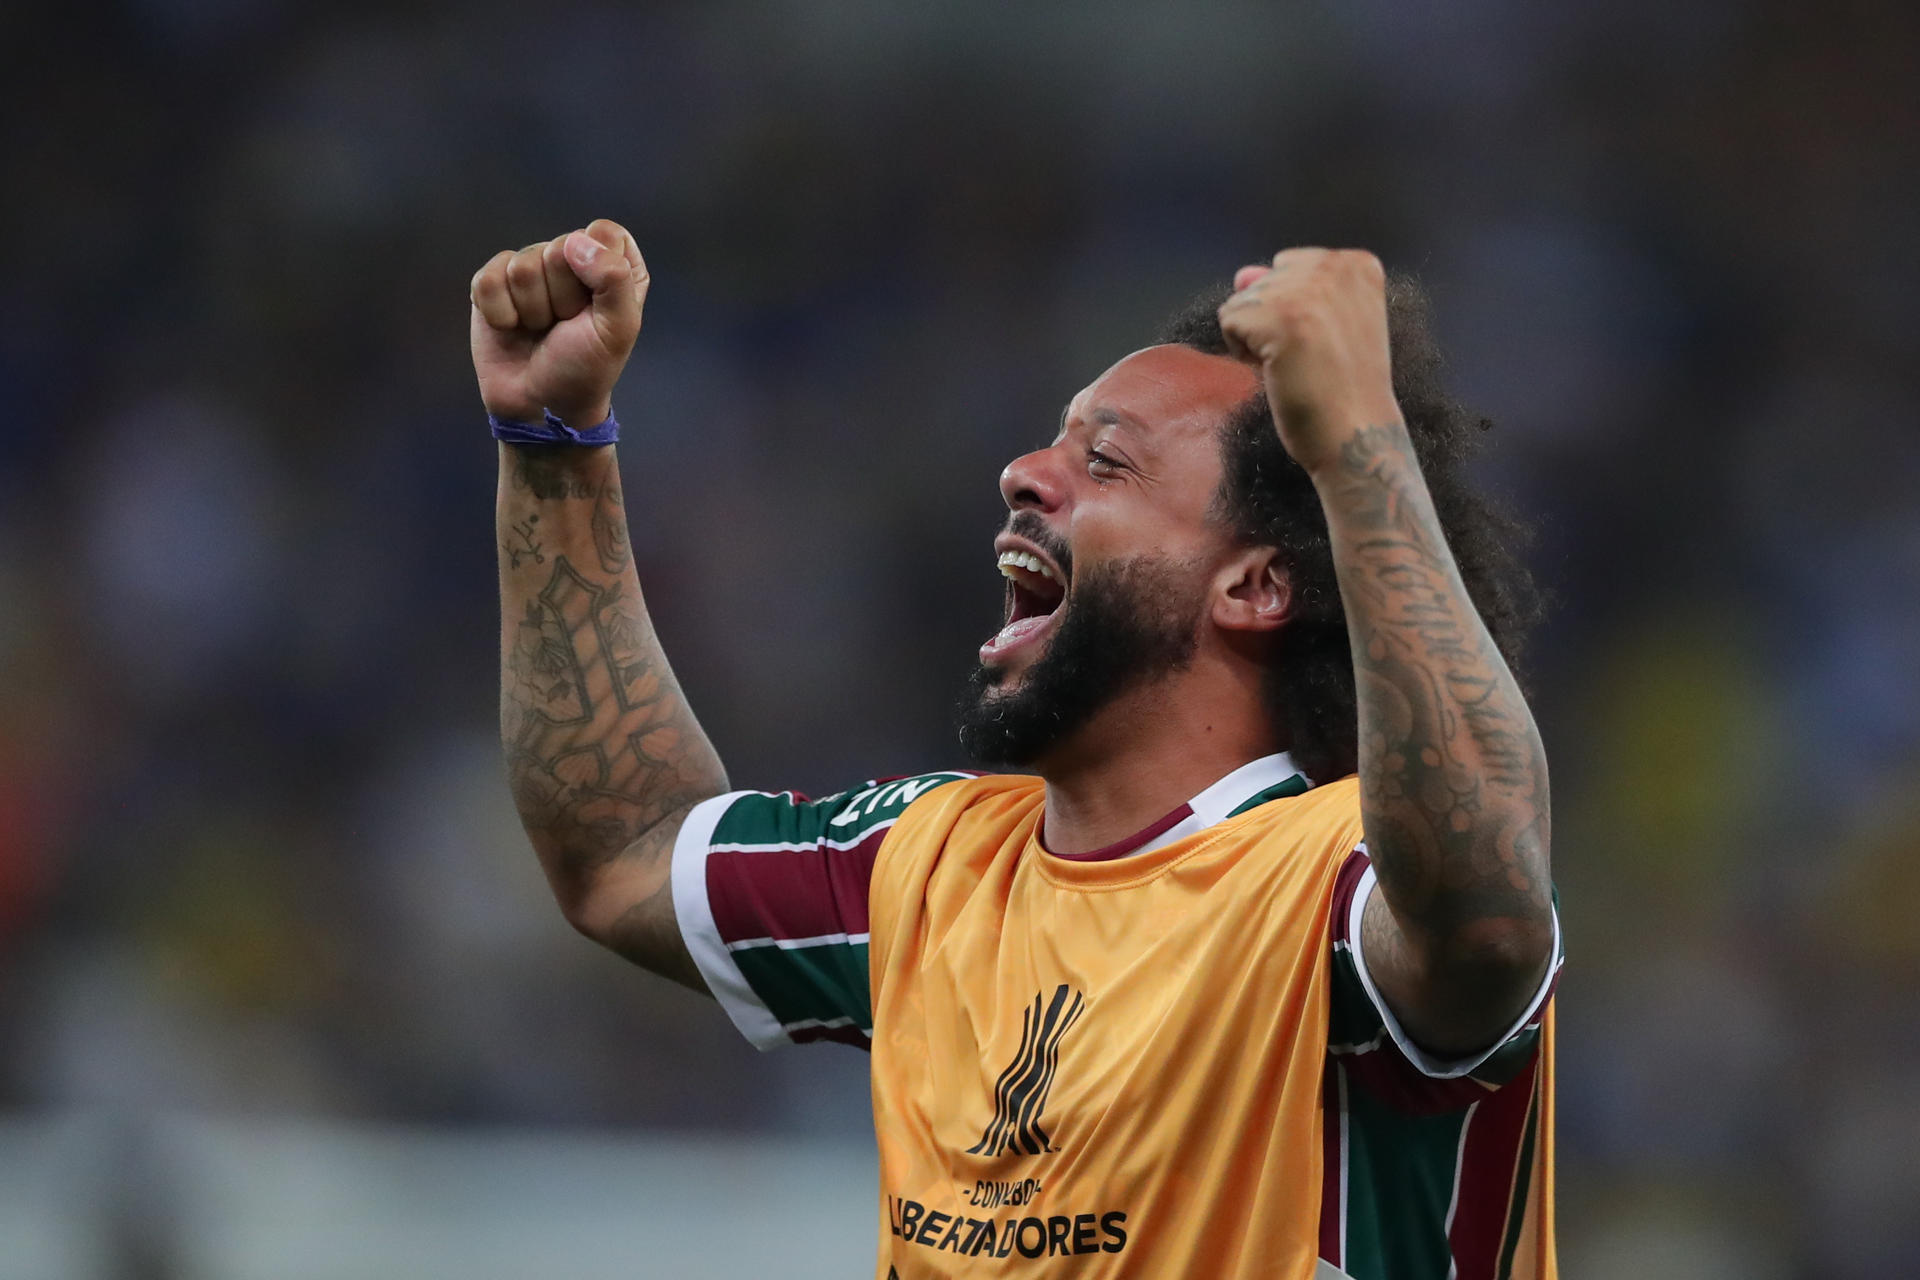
xmin=1066 ymin=345 xmax=1260 ymax=455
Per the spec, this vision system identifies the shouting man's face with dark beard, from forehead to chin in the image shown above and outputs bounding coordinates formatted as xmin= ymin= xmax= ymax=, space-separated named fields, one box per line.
xmin=960 ymin=345 xmax=1258 ymax=766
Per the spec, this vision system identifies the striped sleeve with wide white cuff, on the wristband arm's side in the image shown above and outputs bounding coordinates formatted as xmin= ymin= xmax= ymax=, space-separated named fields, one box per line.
xmin=672 ymin=773 xmax=972 ymax=1050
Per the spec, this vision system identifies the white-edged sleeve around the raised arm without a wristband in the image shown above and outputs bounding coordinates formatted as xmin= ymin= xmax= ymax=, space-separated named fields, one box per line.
xmin=1327 ymin=844 xmax=1565 ymax=1111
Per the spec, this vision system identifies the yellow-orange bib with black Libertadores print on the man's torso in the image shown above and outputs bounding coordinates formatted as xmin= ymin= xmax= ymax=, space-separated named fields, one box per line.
xmin=870 ymin=777 xmax=1361 ymax=1280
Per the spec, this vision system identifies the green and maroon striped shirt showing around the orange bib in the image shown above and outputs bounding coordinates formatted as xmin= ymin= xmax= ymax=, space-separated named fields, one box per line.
xmin=672 ymin=754 xmax=1561 ymax=1280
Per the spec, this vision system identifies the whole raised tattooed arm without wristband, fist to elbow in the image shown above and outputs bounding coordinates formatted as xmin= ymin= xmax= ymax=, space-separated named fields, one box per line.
xmin=1221 ymin=249 xmax=1553 ymax=1055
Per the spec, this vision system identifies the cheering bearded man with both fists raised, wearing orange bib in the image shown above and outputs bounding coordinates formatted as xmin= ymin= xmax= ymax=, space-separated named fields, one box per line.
xmin=472 ymin=221 xmax=1559 ymax=1280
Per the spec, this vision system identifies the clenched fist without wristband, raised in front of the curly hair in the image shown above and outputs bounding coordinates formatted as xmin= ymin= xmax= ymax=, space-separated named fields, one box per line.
xmin=1219 ymin=249 xmax=1400 ymax=472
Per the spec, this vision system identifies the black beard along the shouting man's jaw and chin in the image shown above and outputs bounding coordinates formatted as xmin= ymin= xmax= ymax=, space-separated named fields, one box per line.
xmin=958 ymin=555 xmax=1202 ymax=768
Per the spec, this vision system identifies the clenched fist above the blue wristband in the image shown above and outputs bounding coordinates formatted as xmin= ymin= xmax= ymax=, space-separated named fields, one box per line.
xmin=468 ymin=219 xmax=647 ymax=428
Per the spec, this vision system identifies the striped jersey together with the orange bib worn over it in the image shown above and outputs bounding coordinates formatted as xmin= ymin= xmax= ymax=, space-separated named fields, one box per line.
xmin=672 ymin=754 xmax=1561 ymax=1280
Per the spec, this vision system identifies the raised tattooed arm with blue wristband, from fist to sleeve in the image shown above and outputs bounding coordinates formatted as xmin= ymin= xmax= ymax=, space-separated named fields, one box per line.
xmin=470 ymin=221 xmax=728 ymax=990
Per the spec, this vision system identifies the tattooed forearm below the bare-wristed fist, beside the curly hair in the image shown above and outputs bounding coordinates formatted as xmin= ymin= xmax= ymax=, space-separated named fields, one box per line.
xmin=1327 ymin=424 xmax=1549 ymax=1043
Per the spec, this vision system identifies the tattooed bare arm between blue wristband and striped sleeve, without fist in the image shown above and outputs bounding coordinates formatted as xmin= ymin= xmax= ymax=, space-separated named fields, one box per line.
xmin=499 ymin=447 xmax=726 ymax=986
